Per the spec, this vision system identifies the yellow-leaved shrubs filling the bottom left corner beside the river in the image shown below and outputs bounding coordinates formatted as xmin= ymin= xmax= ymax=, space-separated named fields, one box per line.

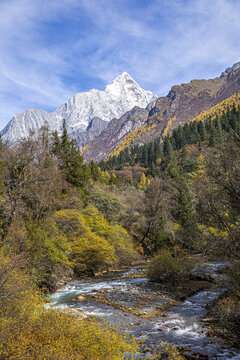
xmin=0 ymin=255 xmax=138 ymax=360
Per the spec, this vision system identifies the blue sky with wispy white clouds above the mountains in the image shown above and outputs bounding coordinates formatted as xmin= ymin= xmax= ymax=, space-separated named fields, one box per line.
xmin=0 ymin=0 xmax=240 ymax=128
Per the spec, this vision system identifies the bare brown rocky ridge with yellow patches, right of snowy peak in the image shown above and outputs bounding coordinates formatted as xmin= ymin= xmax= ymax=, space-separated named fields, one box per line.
xmin=84 ymin=62 xmax=240 ymax=160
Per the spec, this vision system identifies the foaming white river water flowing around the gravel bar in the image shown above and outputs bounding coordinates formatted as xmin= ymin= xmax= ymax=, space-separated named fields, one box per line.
xmin=50 ymin=263 xmax=240 ymax=360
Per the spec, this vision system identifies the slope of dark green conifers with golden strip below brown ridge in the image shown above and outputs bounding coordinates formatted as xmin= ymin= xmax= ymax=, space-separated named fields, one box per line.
xmin=100 ymin=94 xmax=240 ymax=176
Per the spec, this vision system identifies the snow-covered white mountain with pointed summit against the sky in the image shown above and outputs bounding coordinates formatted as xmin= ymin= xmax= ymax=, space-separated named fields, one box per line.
xmin=1 ymin=72 xmax=157 ymax=142
